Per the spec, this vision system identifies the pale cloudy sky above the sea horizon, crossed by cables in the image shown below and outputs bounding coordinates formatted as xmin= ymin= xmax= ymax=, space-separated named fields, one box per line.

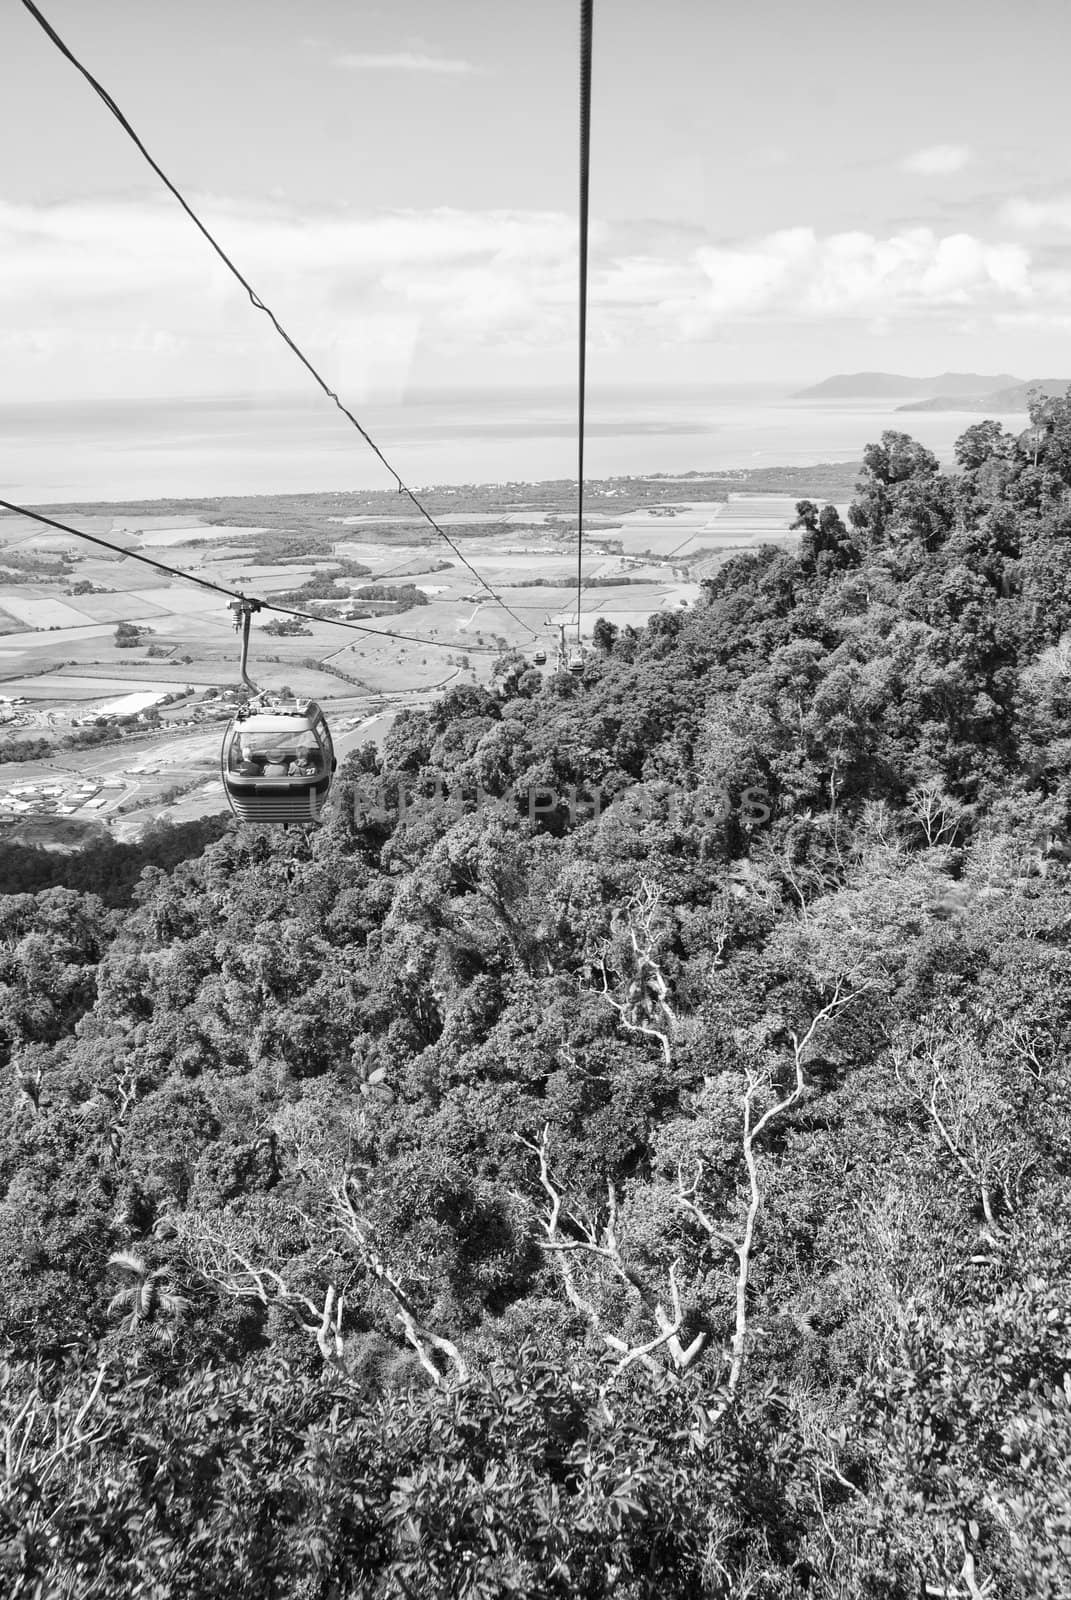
xmin=0 ymin=0 xmax=1071 ymax=403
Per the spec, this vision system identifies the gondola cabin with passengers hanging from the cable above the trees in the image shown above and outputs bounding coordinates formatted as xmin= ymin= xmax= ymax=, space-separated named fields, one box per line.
xmin=221 ymin=699 xmax=338 ymax=822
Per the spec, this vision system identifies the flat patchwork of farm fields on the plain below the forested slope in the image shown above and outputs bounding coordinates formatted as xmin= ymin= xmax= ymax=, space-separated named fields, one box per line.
xmin=0 ymin=478 xmax=804 ymax=837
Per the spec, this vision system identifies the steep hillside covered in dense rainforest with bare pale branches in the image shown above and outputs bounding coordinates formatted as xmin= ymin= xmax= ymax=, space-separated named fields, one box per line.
xmin=0 ymin=402 xmax=1071 ymax=1600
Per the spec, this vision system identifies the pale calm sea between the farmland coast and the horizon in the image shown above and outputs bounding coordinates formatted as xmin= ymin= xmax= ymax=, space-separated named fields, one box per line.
xmin=0 ymin=384 xmax=1026 ymax=506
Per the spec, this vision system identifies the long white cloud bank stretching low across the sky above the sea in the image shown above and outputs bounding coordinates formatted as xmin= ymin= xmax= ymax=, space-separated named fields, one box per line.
xmin=0 ymin=197 xmax=1071 ymax=395
